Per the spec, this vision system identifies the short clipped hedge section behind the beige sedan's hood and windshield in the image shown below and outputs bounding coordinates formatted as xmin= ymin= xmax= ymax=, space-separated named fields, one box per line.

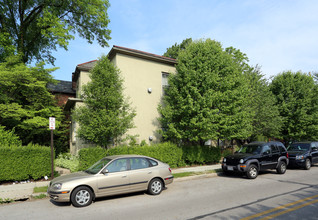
xmin=78 ymin=147 xmax=106 ymax=170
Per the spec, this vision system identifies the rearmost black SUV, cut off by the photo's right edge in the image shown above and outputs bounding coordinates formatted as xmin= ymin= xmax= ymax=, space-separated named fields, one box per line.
xmin=287 ymin=142 xmax=318 ymax=170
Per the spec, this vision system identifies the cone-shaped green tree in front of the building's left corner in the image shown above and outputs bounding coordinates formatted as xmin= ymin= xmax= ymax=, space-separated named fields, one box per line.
xmin=72 ymin=56 xmax=136 ymax=147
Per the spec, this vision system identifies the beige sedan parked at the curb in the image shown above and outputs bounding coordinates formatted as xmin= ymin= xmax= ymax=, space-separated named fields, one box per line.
xmin=48 ymin=155 xmax=173 ymax=207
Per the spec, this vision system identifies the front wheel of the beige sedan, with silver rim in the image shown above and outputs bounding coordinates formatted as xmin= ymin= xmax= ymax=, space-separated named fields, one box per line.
xmin=71 ymin=186 xmax=93 ymax=207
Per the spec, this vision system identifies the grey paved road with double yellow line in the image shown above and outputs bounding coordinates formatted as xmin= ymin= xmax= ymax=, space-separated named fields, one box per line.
xmin=0 ymin=166 xmax=318 ymax=220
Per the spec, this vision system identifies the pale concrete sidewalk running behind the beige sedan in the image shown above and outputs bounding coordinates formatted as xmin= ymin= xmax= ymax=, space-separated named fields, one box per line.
xmin=0 ymin=164 xmax=221 ymax=200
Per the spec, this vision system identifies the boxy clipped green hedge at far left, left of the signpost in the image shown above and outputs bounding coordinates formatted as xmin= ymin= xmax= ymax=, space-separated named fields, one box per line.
xmin=0 ymin=145 xmax=51 ymax=182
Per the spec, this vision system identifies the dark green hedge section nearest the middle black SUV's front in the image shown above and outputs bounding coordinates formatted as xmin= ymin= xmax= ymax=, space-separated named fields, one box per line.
xmin=182 ymin=145 xmax=221 ymax=164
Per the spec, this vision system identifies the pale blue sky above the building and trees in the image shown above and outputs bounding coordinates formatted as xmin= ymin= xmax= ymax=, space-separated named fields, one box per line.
xmin=47 ymin=0 xmax=318 ymax=81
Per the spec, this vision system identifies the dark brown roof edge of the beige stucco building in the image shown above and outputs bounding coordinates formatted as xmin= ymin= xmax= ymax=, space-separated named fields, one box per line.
xmin=73 ymin=45 xmax=177 ymax=81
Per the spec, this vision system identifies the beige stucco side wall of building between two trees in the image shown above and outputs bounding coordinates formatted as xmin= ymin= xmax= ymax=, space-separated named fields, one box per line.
xmin=113 ymin=54 xmax=176 ymax=143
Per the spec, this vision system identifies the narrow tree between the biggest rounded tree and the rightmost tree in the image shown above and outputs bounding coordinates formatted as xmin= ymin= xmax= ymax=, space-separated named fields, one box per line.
xmin=247 ymin=66 xmax=282 ymax=141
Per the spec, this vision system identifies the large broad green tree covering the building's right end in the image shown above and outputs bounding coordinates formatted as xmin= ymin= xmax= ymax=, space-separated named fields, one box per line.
xmin=158 ymin=39 xmax=252 ymax=144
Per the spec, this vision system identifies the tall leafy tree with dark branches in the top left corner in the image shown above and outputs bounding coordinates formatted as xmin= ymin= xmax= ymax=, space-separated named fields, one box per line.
xmin=0 ymin=0 xmax=110 ymax=63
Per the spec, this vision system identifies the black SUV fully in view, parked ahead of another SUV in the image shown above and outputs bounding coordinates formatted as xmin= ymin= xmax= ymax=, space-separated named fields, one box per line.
xmin=222 ymin=141 xmax=289 ymax=179
